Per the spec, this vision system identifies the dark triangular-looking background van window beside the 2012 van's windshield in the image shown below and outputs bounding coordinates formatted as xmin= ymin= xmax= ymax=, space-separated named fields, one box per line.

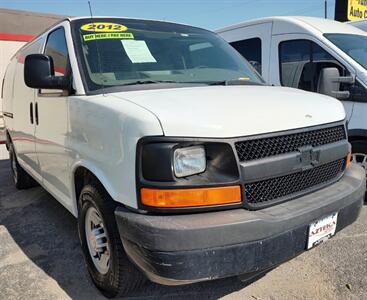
xmin=230 ymin=38 xmax=261 ymax=74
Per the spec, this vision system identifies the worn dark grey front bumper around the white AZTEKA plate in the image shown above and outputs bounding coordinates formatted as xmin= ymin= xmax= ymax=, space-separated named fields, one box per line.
xmin=115 ymin=164 xmax=366 ymax=285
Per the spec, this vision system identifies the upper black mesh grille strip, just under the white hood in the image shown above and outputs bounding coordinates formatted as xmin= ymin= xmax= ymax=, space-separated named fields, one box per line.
xmin=235 ymin=125 xmax=346 ymax=161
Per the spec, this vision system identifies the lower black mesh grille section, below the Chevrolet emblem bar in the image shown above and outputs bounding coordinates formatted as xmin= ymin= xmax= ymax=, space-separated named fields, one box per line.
xmin=244 ymin=159 xmax=345 ymax=206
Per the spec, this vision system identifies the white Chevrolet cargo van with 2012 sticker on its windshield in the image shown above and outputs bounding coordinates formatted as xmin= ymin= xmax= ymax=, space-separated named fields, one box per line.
xmin=4 ymin=17 xmax=365 ymax=297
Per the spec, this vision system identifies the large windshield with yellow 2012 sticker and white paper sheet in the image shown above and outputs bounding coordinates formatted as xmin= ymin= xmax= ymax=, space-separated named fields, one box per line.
xmin=72 ymin=18 xmax=263 ymax=91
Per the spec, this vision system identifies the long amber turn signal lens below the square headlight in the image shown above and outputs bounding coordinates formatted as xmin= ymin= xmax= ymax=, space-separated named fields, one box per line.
xmin=140 ymin=186 xmax=241 ymax=208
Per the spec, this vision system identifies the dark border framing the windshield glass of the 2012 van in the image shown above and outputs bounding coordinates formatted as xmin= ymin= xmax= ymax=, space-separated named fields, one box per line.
xmin=70 ymin=17 xmax=265 ymax=95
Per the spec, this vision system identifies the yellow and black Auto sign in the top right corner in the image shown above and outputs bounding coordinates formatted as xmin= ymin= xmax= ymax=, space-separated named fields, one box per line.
xmin=335 ymin=0 xmax=367 ymax=22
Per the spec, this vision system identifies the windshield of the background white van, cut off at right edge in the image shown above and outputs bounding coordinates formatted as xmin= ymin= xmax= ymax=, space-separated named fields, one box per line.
xmin=324 ymin=33 xmax=367 ymax=69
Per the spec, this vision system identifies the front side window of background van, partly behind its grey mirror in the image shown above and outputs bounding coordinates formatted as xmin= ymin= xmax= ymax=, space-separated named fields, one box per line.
xmin=279 ymin=40 xmax=347 ymax=92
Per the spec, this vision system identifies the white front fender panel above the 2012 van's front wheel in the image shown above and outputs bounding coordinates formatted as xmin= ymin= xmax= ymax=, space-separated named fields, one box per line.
xmin=66 ymin=95 xmax=163 ymax=214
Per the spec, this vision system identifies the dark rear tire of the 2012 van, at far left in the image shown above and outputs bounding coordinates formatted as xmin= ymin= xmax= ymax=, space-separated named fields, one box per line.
xmin=9 ymin=143 xmax=37 ymax=190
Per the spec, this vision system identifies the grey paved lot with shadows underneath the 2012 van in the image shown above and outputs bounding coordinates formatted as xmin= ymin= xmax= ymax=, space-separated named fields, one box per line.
xmin=0 ymin=155 xmax=367 ymax=299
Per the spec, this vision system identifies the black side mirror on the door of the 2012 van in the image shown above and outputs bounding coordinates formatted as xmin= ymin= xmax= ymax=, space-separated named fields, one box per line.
xmin=24 ymin=54 xmax=70 ymax=90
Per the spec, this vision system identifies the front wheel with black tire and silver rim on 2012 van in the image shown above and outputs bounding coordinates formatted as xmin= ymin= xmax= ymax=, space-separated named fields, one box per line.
xmin=78 ymin=183 xmax=145 ymax=298
